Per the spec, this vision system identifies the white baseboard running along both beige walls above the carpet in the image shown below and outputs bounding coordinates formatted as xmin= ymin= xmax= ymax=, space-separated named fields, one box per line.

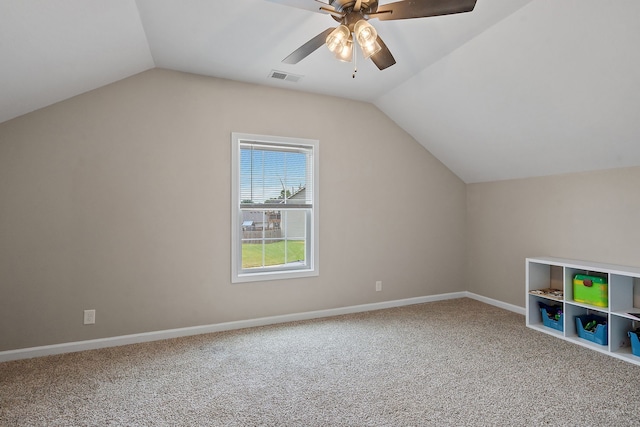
xmin=0 ymin=291 xmax=525 ymax=362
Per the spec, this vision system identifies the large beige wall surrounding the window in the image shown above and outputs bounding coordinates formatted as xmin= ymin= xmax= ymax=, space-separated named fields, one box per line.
xmin=0 ymin=70 xmax=464 ymax=350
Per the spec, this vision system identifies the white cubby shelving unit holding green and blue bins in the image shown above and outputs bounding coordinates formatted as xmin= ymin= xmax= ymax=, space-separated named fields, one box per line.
xmin=526 ymin=257 xmax=640 ymax=365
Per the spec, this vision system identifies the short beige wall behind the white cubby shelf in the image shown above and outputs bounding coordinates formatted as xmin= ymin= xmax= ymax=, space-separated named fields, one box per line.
xmin=467 ymin=167 xmax=640 ymax=307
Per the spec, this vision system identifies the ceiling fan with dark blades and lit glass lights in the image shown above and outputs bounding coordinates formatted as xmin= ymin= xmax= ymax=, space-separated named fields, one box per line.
xmin=267 ymin=0 xmax=476 ymax=72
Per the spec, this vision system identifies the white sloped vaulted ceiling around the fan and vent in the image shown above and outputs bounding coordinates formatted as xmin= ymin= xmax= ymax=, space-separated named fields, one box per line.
xmin=0 ymin=0 xmax=640 ymax=183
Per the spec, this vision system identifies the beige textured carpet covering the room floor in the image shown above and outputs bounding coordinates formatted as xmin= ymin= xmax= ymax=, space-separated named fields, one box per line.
xmin=0 ymin=299 xmax=640 ymax=426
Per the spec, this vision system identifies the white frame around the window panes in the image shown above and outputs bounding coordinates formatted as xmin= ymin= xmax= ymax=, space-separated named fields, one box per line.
xmin=231 ymin=132 xmax=320 ymax=283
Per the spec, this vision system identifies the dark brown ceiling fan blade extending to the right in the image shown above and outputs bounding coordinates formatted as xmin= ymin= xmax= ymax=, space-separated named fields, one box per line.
xmin=370 ymin=0 xmax=476 ymax=21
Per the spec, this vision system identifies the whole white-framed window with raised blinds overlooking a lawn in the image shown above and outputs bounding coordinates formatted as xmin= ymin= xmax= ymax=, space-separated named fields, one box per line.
xmin=231 ymin=133 xmax=319 ymax=283
